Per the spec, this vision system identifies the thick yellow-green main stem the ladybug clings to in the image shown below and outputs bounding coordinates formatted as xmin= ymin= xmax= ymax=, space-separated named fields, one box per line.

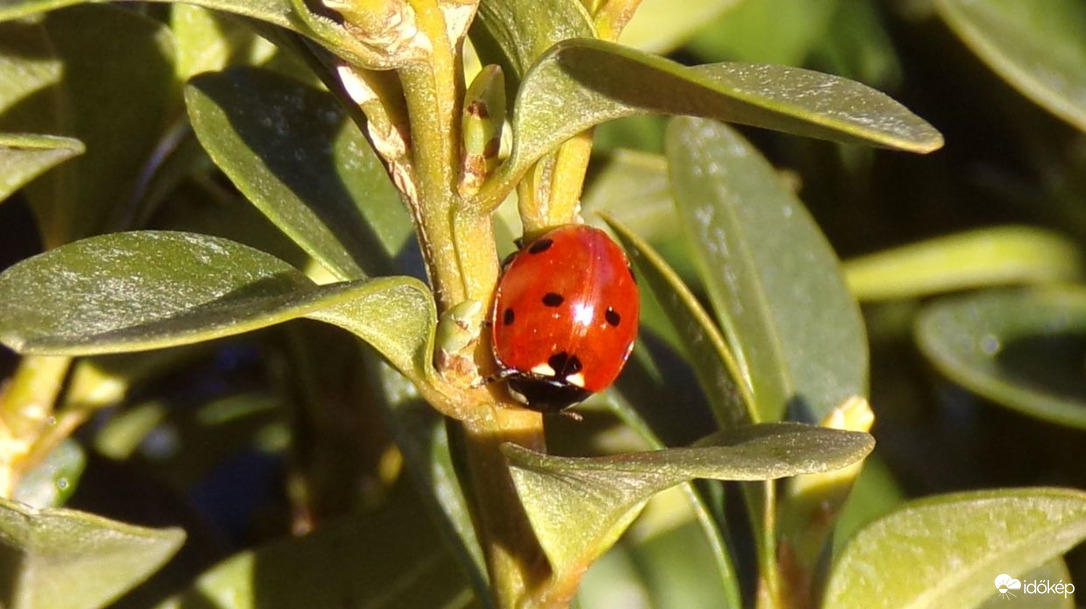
xmin=400 ymin=5 xmax=550 ymax=609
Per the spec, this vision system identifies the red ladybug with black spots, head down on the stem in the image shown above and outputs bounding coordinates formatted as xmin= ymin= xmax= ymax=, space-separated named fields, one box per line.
xmin=491 ymin=225 xmax=641 ymax=413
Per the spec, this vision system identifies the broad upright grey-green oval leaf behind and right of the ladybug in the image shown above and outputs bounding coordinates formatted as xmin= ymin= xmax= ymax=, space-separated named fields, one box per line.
xmin=667 ymin=118 xmax=868 ymax=422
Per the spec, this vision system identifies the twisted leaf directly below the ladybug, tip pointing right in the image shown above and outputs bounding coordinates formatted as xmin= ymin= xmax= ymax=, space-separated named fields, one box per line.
xmin=504 ymin=423 xmax=874 ymax=574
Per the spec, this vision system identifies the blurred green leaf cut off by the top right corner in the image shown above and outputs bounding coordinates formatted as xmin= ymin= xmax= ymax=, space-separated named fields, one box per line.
xmin=935 ymin=0 xmax=1086 ymax=131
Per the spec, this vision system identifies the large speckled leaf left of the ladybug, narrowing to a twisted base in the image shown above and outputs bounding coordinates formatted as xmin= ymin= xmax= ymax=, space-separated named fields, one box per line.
xmin=0 ymin=231 xmax=435 ymax=381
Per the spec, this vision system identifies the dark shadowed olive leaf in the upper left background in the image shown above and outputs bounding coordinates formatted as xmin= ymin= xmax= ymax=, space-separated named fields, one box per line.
xmin=0 ymin=5 xmax=179 ymax=248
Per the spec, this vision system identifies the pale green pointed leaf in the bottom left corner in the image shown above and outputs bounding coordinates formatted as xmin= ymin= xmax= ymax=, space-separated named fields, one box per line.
xmin=0 ymin=499 xmax=185 ymax=609
